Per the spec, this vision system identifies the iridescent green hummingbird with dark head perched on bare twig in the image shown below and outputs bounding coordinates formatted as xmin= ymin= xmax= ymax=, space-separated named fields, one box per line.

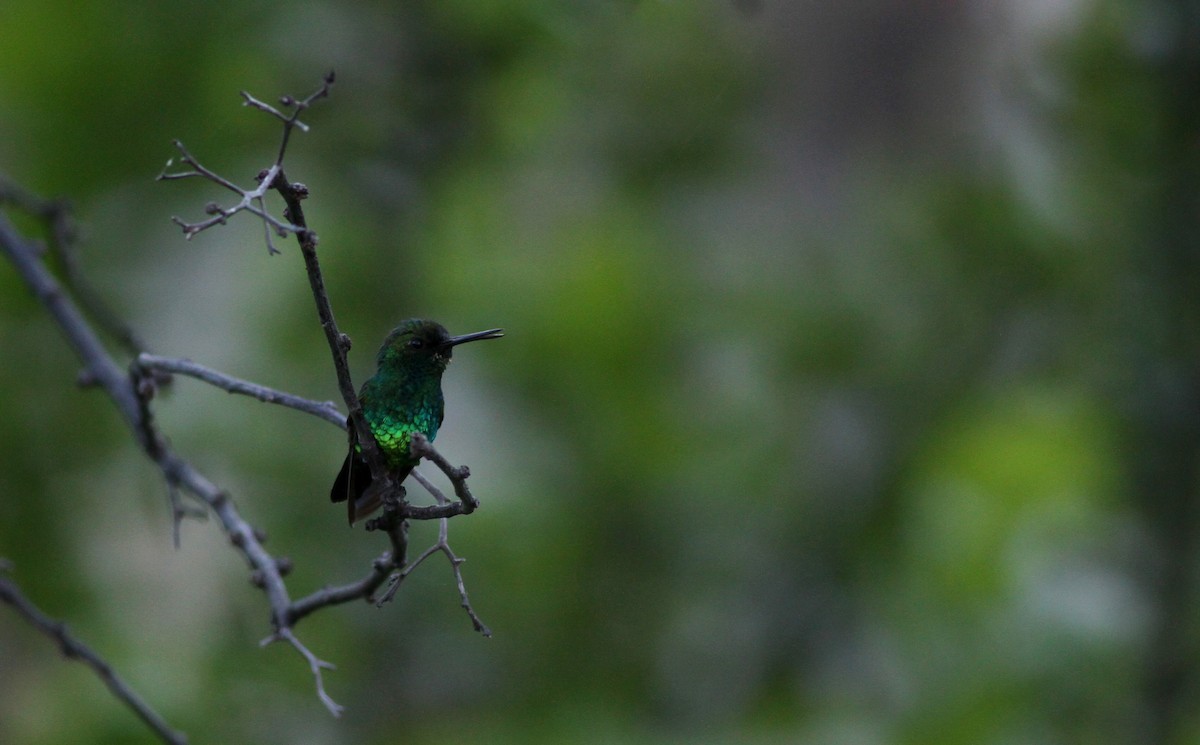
xmin=329 ymin=318 xmax=504 ymax=525
